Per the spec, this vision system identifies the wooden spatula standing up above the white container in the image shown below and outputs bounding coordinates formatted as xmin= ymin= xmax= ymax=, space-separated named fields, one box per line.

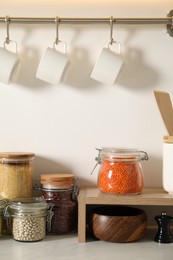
xmin=154 ymin=90 xmax=173 ymax=136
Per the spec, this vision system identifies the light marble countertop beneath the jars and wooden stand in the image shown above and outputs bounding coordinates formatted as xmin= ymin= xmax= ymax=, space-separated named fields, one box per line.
xmin=0 ymin=230 xmax=173 ymax=260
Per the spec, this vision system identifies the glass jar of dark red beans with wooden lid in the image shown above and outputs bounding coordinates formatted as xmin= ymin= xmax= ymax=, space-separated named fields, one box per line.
xmin=40 ymin=173 xmax=78 ymax=235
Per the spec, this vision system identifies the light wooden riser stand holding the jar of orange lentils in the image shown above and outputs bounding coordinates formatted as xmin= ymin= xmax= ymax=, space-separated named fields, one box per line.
xmin=78 ymin=188 xmax=173 ymax=243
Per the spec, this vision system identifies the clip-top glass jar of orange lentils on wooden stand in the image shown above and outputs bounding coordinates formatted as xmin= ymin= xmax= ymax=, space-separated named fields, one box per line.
xmin=96 ymin=147 xmax=148 ymax=194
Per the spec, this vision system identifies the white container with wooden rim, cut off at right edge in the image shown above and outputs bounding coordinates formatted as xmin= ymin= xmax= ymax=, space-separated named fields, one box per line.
xmin=163 ymin=136 xmax=173 ymax=194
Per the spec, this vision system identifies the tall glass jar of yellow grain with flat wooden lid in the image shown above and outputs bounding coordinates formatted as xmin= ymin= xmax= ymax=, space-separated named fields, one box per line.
xmin=0 ymin=153 xmax=35 ymax=200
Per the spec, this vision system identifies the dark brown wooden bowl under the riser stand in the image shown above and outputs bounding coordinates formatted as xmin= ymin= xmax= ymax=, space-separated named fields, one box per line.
xmin=91 ymin=206 xmax=147 ymax=242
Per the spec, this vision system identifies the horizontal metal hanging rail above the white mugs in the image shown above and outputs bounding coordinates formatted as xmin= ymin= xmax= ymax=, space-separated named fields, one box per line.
xmin=0 ymin=10 xmax=173 ymax=36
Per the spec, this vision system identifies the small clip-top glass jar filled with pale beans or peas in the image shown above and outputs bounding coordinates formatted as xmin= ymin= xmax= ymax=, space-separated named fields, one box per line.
xmin=5 ymin=197 xmax=48 ymax=242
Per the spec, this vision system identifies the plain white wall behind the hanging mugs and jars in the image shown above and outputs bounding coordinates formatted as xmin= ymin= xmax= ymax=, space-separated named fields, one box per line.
xmin=0 ymin=0 xmax=173 ymax=190
